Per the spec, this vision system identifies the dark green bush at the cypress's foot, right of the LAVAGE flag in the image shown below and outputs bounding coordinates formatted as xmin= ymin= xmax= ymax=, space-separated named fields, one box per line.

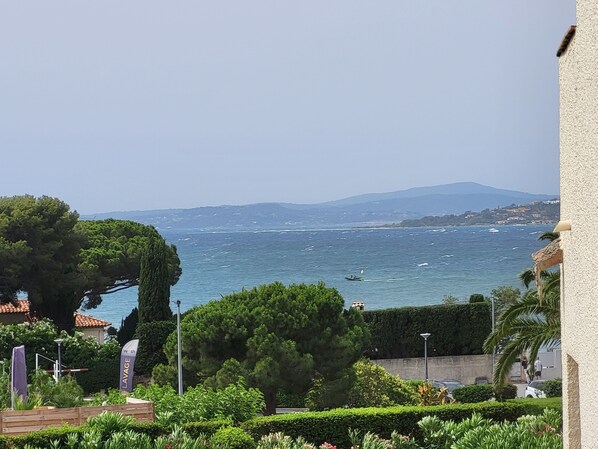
xmin=135 ymin=320 xmax=176 ymax=374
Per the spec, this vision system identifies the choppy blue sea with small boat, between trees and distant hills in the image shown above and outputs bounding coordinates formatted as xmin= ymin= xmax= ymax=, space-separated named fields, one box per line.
xmin=91 ymin=225 xmax=552 ymax=328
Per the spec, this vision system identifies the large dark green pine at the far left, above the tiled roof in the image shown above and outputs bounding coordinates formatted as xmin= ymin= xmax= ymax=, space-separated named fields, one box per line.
xmin=0 ymin=195 xmax=83 ymax=329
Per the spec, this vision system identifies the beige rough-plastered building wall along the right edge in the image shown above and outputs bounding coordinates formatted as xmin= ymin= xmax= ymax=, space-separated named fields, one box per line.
xmin=559 ymin=0 xmax=598 ymax=448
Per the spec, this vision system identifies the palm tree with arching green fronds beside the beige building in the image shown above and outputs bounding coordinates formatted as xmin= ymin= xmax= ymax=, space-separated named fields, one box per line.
xmin=484 ymin=233 xmax=561 ymax=385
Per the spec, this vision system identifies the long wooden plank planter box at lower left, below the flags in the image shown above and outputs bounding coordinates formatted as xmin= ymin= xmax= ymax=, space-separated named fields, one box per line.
xmin=0 ymin=398 xmax=154 ymax=435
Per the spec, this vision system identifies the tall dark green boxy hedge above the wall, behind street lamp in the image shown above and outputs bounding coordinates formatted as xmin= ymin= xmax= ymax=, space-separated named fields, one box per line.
xmin=363 ymin=302 xmax=492 ymax=359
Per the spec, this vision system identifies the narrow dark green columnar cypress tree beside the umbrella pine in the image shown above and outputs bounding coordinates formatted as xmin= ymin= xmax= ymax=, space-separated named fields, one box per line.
xmin=139 ymin=234 xmax=172 ymax=323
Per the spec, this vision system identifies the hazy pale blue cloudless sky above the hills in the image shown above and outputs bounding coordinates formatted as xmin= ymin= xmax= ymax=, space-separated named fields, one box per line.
xmin=0 ymin=0 xmax=575 ymax=213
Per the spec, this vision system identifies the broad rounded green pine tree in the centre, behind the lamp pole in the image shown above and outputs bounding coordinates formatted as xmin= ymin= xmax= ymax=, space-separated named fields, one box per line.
xmin=165 ymin=282 xmax=368 ymax=413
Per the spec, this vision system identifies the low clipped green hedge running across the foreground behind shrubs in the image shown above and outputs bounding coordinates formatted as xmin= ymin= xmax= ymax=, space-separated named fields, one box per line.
xmin=0 ymin=398 xmax=562 ymax=449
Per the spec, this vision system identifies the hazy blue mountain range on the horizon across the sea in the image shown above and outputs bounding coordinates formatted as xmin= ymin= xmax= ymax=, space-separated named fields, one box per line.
xmin=82 ymin=182 xmax=556 ymax=230
